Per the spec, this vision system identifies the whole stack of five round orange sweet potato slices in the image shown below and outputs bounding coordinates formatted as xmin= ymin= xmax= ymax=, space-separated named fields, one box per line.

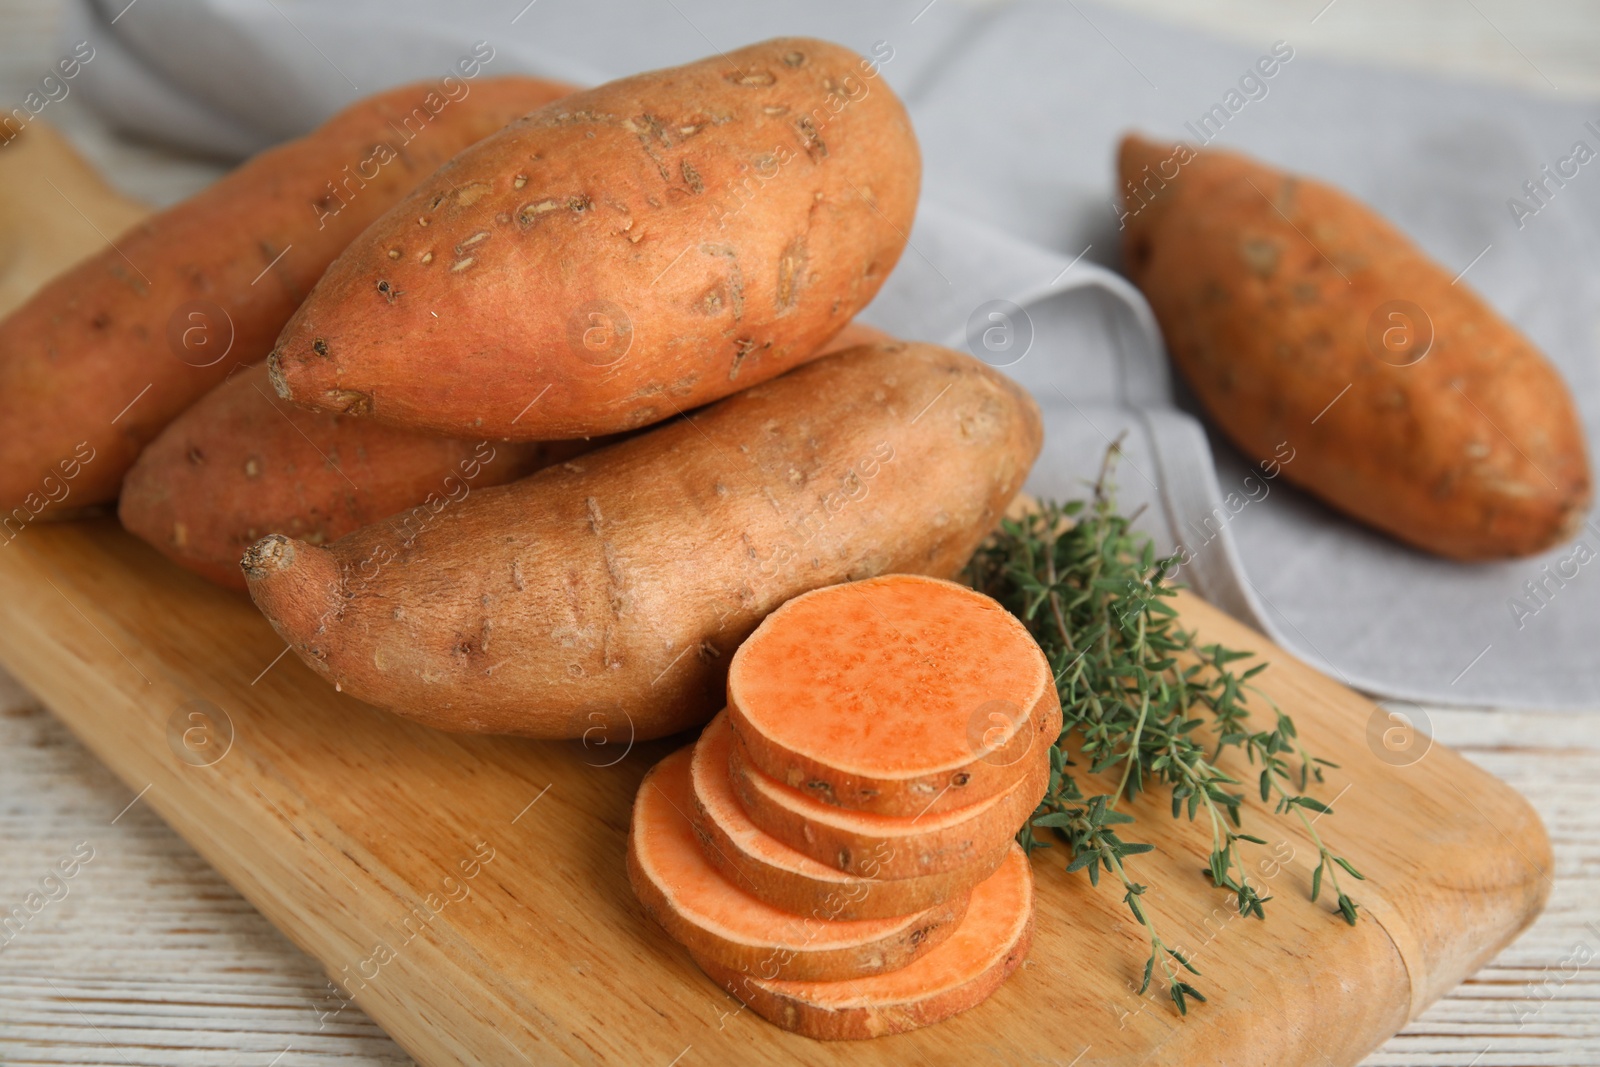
xmin=629 ymin=574 xmax=1061 ymax=1038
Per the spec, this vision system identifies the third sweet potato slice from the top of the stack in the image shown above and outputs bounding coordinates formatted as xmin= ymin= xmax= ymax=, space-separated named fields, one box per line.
xmin=690 ymin=713 xmax=1006 ymax=920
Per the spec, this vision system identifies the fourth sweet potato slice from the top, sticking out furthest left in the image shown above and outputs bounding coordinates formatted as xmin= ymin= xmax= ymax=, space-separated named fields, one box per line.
xmin=627 ymin=745 xmax=966 ymax=981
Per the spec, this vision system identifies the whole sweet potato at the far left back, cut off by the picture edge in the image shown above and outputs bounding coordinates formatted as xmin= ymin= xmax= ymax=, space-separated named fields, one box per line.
xmin=0 ymin=77 xmax=570 ymax=518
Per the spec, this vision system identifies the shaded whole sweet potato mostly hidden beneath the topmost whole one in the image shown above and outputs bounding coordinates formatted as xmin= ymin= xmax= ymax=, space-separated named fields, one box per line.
xmin=117 ymin=363 xmax=597 ymax=590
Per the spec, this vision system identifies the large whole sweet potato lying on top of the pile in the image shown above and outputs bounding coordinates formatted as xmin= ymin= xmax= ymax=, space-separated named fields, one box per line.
xmin=270 ymin=38 xmax=922 ymax=440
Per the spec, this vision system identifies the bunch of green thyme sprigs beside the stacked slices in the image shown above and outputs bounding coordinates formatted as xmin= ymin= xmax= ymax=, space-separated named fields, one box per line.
xmin=968 ymin=445 xmax=1362 ymax=1014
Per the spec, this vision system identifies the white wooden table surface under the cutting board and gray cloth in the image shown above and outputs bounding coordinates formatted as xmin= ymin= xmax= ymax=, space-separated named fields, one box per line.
xmin=0 ymin=0 xmax=1600 ymax=1067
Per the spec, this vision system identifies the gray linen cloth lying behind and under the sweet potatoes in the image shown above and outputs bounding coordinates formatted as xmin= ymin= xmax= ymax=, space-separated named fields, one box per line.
xmin=62 ymin=0 xmax=1600 ymax=709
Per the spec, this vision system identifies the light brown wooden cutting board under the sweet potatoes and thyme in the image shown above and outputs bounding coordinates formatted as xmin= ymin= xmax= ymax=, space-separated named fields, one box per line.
xmin=0 ymin=520 xmax=1550 ymax=1067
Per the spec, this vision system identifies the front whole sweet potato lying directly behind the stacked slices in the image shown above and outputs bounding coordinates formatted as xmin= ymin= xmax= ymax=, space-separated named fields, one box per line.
xmin=236 ymin=342 xmax=1042 ymax=741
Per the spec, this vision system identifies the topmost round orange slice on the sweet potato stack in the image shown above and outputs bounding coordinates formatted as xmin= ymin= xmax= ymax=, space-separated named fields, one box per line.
xmin=728 ymin=574 xmax=1061 ymax=816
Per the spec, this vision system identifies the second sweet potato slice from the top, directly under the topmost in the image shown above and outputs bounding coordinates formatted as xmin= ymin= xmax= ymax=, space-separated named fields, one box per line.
xmin=728 ymin=734 xmax=1050 ymax=878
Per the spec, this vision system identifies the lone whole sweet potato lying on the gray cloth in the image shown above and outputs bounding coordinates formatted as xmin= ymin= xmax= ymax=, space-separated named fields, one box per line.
xmin=1120 ymin=138 xmax=1592 ymax=560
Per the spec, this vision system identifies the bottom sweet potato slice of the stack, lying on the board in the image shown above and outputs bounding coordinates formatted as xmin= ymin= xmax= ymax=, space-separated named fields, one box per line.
xmin=696 ymin=845 xmax=1034 ymax=1041
